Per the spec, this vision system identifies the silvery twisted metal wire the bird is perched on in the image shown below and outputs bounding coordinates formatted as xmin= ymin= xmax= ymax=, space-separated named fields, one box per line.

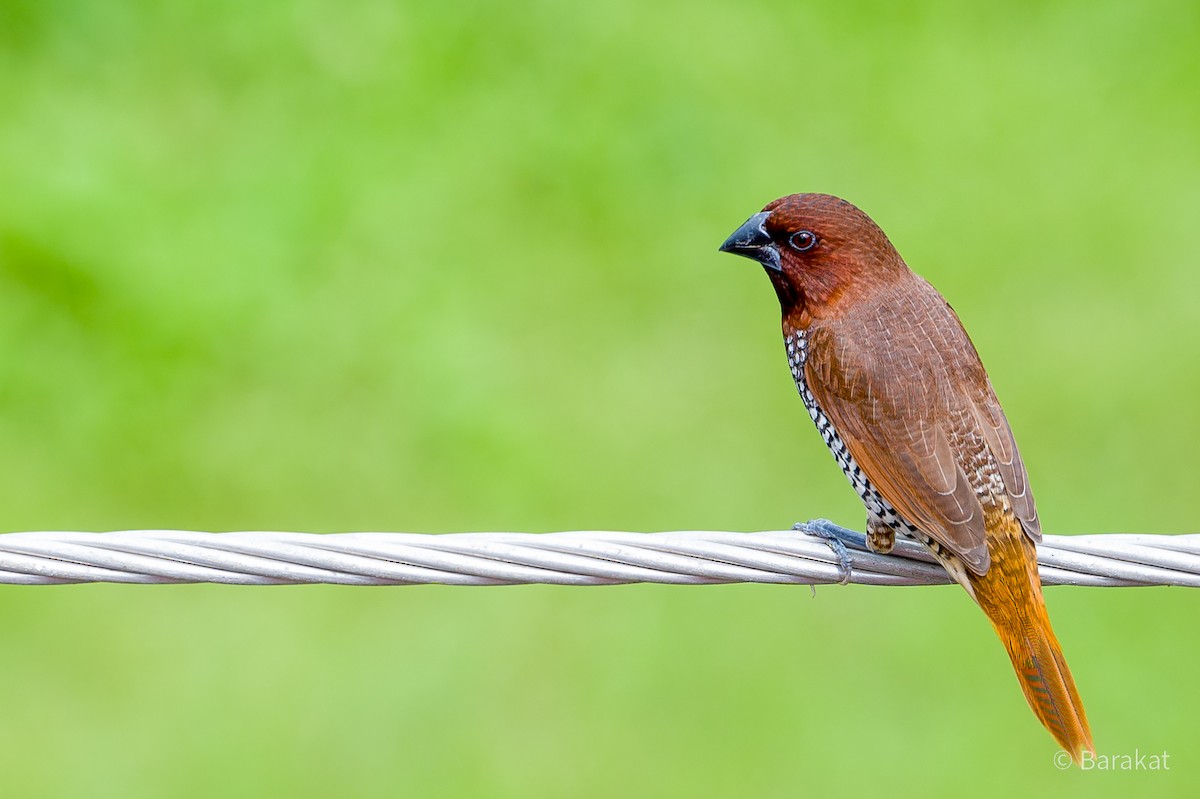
xmin=0 ymin=521 xmax=1200 ymax=587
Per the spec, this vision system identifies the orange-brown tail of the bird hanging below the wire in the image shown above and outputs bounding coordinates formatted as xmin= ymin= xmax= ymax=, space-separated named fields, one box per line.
xmin=968 ymin=517 xmax=1096 ymax=763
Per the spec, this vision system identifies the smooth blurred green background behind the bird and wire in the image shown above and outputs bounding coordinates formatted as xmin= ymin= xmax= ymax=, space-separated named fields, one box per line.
xmin=0 ymin=0 xmax=1200 ymax=797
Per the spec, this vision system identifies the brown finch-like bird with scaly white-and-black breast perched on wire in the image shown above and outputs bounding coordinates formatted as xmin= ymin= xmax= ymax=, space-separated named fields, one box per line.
xmin=720 ymin=193 xmax=1096 ymax=763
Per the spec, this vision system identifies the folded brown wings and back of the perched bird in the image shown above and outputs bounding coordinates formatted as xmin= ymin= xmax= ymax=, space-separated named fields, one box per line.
xmin=805 ymin=295 xmax=1039 ymax=575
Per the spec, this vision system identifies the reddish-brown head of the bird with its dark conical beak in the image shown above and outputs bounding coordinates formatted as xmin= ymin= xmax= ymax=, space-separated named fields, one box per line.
xmin=721 ymin=194 xmax=911 ymax=318
